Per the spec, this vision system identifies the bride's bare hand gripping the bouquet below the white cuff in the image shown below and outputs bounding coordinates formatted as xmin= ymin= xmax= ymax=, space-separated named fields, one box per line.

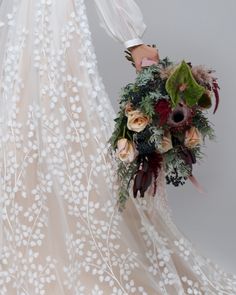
xmin=129 ymin=44 xmax=160 ymax=72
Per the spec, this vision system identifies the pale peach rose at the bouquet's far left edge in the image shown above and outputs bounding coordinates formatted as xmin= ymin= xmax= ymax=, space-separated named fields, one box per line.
xmin=116 ymin=138 xmax=137 ymax=163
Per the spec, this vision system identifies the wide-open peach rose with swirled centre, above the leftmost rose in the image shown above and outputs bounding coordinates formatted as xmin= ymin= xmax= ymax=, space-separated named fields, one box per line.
xmin=127 ymin=110 xmax=150 ymax=132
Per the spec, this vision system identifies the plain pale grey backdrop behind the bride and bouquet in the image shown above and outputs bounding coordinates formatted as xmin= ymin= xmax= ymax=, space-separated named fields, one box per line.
xmin=85 ymin=0 xmax=236 ymax=274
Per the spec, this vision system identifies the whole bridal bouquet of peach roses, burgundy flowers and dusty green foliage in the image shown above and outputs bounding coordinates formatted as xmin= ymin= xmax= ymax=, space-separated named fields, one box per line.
xmin=109 ymin=51 xmax=219 ymax=210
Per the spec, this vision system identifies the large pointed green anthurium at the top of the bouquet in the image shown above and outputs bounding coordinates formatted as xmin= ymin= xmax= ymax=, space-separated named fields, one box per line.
xmin=166 ymin=61 xmax=205 ymax=106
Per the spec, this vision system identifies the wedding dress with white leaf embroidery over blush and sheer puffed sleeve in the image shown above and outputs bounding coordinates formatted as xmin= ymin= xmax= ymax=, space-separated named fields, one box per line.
xmin=0 ymin=0 xmax=236 ymax=295
